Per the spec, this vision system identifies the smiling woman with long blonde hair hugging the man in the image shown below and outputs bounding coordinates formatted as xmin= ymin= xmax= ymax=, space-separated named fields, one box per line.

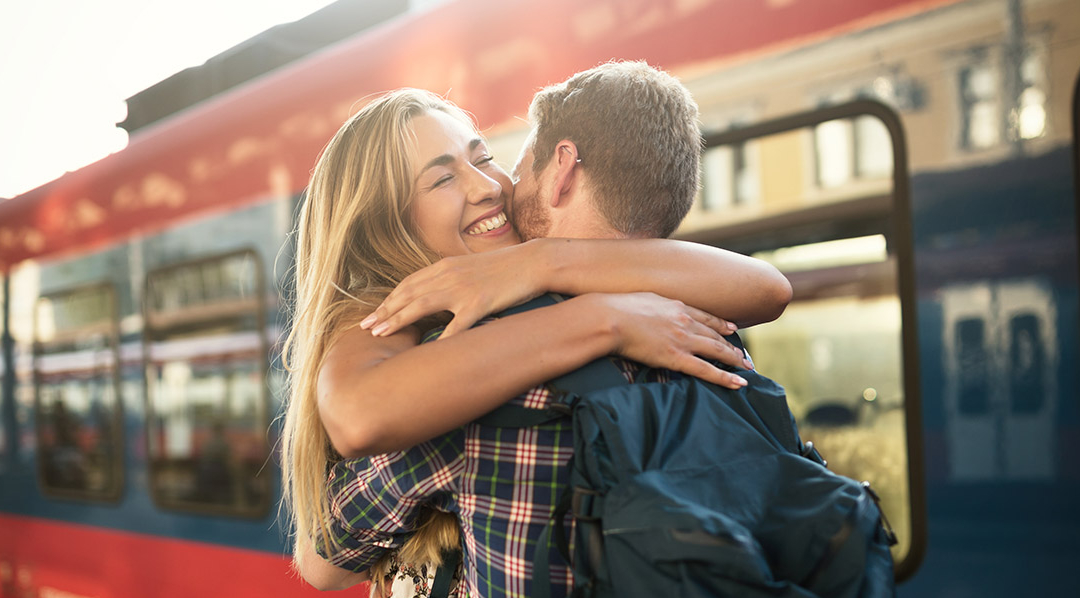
xmin=282 ymin=90 xmax=789 ymax=588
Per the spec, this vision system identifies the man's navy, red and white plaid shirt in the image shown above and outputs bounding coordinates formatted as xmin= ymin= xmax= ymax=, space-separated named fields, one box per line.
xmin=327 ymin=336 xmax=669 ymax=598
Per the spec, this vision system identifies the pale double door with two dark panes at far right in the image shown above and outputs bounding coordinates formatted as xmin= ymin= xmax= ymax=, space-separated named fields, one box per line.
xmin=942 ymin=280 xmax=1057 ymax=481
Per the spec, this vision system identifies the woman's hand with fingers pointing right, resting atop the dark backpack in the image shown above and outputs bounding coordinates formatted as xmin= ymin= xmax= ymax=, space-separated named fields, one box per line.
xmin=588 ymin=293 xmax=754 ymax=389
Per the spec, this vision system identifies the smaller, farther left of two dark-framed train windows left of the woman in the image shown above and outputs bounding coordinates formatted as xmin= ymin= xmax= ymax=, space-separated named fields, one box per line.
xmin=33 ymin=284 xmax=123 ymax=500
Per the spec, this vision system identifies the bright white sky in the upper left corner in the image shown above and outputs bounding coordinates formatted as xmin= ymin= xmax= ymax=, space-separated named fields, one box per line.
xmin=0 ymin=0 xmax=341 ymax=199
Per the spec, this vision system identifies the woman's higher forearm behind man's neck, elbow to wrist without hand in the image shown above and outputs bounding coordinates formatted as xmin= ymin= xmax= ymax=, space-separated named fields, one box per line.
xmin=533 ymin=239 xmax=792 ymax=327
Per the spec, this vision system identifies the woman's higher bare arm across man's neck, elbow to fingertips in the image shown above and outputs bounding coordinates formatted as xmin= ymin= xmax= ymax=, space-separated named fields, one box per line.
xmin=363 ymin=239 xmax=792 ymax=337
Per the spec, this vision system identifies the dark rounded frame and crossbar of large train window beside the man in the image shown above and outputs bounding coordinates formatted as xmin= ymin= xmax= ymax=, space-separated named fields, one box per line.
xmin=680 ymin=98 xmax=927 ymax=582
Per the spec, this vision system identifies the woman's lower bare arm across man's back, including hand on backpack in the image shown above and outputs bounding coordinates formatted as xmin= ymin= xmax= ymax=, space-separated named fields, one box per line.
xmin=318 ymin=294 xmax=746 ymax=458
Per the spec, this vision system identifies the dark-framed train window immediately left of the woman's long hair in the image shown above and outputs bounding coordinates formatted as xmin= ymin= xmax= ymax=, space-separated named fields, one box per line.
xmin=144 ymin=252 xmax=270 ymax=516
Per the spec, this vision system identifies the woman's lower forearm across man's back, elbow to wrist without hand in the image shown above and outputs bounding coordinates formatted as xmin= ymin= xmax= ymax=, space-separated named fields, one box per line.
xmin=319 ymin=296 xmax=619 ymax=458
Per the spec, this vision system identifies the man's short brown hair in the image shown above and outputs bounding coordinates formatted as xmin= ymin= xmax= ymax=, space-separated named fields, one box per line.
xmin=529 ymin=62 xmax=702 ymax=236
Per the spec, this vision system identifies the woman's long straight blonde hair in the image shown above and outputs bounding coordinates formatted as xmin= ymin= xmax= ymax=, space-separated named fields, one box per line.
xmin=281 ymin=89 xmax=475 ymax=583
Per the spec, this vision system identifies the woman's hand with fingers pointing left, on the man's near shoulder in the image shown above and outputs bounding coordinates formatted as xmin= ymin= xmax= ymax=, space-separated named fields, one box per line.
xmin=360 ymin=243 xmax=548 ymax=339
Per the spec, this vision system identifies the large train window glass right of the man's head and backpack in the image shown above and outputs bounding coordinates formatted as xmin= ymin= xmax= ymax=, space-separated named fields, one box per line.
xmin=679 ymin=100 xmax=924 ymax=577
